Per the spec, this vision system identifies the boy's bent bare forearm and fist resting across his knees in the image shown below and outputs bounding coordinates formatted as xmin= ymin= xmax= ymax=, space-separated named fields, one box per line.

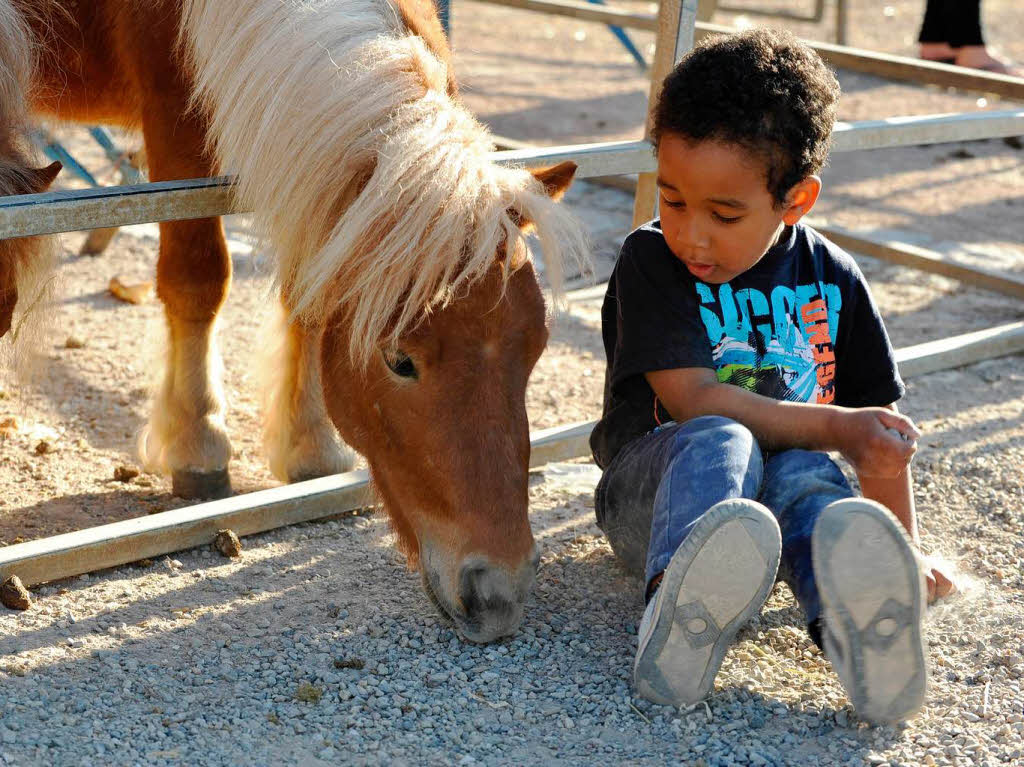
xmin=644 ymin=368 xmax=921 ymax=477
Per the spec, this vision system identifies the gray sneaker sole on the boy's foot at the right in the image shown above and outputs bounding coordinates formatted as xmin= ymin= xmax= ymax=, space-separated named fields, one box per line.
xmin=811 ymin=498 xmax=928 ymax=724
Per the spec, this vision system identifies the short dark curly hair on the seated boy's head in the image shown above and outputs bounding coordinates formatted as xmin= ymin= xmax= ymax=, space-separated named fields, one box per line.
xmin=651 ymin=29 xmax=840 ymax=204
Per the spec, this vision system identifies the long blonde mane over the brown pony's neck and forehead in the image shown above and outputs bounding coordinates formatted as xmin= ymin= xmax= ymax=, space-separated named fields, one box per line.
xmin=182 ymin=0 xmax=586 ymax=365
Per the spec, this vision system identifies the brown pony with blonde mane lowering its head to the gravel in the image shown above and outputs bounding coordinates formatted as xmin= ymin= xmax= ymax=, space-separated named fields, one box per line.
xmin=0 ymin=0 xmax=587 ymax=642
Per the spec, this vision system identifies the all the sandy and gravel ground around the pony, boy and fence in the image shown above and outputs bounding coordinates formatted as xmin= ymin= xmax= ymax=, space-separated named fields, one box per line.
xmin=0 ymin=0 xmax=1024 ymax=765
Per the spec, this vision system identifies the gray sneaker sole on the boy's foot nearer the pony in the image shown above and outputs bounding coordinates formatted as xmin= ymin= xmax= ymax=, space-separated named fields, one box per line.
xmin=633 ymin=499 xmax=782 ymax=706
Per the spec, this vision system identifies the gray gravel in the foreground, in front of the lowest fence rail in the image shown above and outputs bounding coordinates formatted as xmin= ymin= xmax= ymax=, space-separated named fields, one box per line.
xmin=0 ymin=442 xmax=1024 ymax=765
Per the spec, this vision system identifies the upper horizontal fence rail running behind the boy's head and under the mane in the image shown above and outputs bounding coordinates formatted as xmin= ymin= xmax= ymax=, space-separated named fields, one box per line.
xmin=0 ymin=110 xmax=1024 ymax=240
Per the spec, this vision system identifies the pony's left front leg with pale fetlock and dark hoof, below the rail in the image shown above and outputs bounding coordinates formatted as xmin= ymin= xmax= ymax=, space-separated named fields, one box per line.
xmin=139 ymin=218 xmax=231 ymax=498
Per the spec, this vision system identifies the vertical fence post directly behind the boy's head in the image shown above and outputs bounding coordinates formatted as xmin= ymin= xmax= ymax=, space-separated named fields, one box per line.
xmin=633 ymin=0 xmax=697 ymax=228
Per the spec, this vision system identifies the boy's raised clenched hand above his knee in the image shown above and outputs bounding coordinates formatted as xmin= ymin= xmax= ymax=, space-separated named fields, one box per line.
xmin=834 ymin=408 xmax=921 ymax=477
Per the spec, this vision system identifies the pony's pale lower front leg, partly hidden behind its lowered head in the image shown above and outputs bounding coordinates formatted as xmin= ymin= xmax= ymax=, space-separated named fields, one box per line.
xmin=263 ymin=312 xmax=355 ymax=482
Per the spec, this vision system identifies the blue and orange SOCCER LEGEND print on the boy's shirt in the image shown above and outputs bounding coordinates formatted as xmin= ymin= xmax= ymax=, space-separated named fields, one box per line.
xmin=696 ymin=282 xmax=843 ymax=403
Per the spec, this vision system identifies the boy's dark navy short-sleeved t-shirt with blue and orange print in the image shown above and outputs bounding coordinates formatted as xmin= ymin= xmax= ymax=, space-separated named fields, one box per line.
xmin=590 ymin=220 xmax=905 ymax=467
